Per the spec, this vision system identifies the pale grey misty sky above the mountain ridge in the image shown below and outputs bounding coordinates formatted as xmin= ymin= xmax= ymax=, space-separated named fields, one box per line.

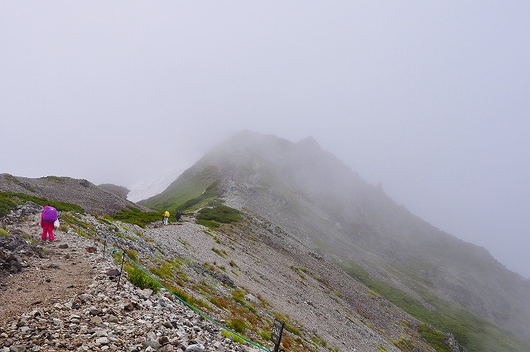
xmin=0 ymin=0 xmax=530 ymax=277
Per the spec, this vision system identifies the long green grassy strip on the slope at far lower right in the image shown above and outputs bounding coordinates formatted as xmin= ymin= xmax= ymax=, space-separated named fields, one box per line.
xmin=338 ymin=261 xmax=530 ymax=352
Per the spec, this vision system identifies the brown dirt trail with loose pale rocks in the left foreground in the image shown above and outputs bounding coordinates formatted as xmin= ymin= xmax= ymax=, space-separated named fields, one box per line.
xmin=0 ymin=206 xmax=257 ymax=352
